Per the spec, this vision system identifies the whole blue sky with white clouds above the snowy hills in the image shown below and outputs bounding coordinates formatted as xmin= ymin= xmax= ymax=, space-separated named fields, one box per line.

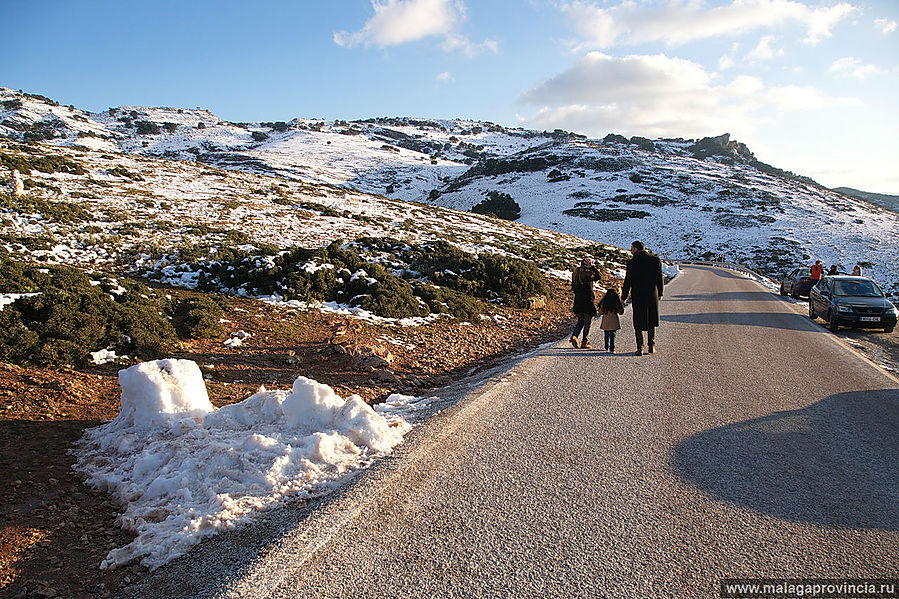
xmin=0 ymin=0 xmax=899 ymax=194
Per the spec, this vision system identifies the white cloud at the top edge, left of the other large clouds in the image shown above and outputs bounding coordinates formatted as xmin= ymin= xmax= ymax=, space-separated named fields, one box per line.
xmin=334 ymin=0 xmax=499 ymax=56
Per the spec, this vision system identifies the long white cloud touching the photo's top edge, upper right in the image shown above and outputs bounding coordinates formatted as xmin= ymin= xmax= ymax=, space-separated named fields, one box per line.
xmin=562 ymin=0 xmax=857 ymax=51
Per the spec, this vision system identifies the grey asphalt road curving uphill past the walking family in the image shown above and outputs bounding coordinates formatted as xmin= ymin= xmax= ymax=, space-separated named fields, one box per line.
xmin=130 ymin=267 xmax=899 ymax=599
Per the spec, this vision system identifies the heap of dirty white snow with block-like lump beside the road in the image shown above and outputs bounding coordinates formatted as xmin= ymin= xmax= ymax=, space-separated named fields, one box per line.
xmin=73 ymin=360 xmax=429 ymax=569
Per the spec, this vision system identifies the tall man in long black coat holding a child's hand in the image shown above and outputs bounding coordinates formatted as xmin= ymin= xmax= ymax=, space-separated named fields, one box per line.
xmin=621 ymin=241 xmax=665 ymax=356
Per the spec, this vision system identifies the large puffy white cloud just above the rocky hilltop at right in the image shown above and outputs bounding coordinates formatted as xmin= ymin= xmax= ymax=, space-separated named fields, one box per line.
xmin=521 ymin=52 xmax=861 ymax=137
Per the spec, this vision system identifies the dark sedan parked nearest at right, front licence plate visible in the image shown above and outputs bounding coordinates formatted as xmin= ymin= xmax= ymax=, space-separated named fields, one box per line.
xmin=808 ymin=276 xmax=897 ymax=333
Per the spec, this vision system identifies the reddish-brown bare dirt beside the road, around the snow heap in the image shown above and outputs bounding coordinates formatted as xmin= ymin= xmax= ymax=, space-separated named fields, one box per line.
xmin=0 ymin=280 xmax=616 ymax=599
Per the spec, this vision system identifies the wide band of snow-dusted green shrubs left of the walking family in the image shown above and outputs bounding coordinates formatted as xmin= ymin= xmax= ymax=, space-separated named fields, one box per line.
xmin=148 ymin=238 xmax=547 ymax=318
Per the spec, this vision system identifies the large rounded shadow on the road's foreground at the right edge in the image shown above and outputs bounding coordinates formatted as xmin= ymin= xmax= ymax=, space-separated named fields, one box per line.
xmin=671 ymin=389 xmax=899 ymax=531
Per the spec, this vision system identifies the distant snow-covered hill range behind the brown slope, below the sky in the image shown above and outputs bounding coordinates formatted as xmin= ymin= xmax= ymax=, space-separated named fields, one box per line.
xmin=0 ymin=90 xmax=899 ymax=294
